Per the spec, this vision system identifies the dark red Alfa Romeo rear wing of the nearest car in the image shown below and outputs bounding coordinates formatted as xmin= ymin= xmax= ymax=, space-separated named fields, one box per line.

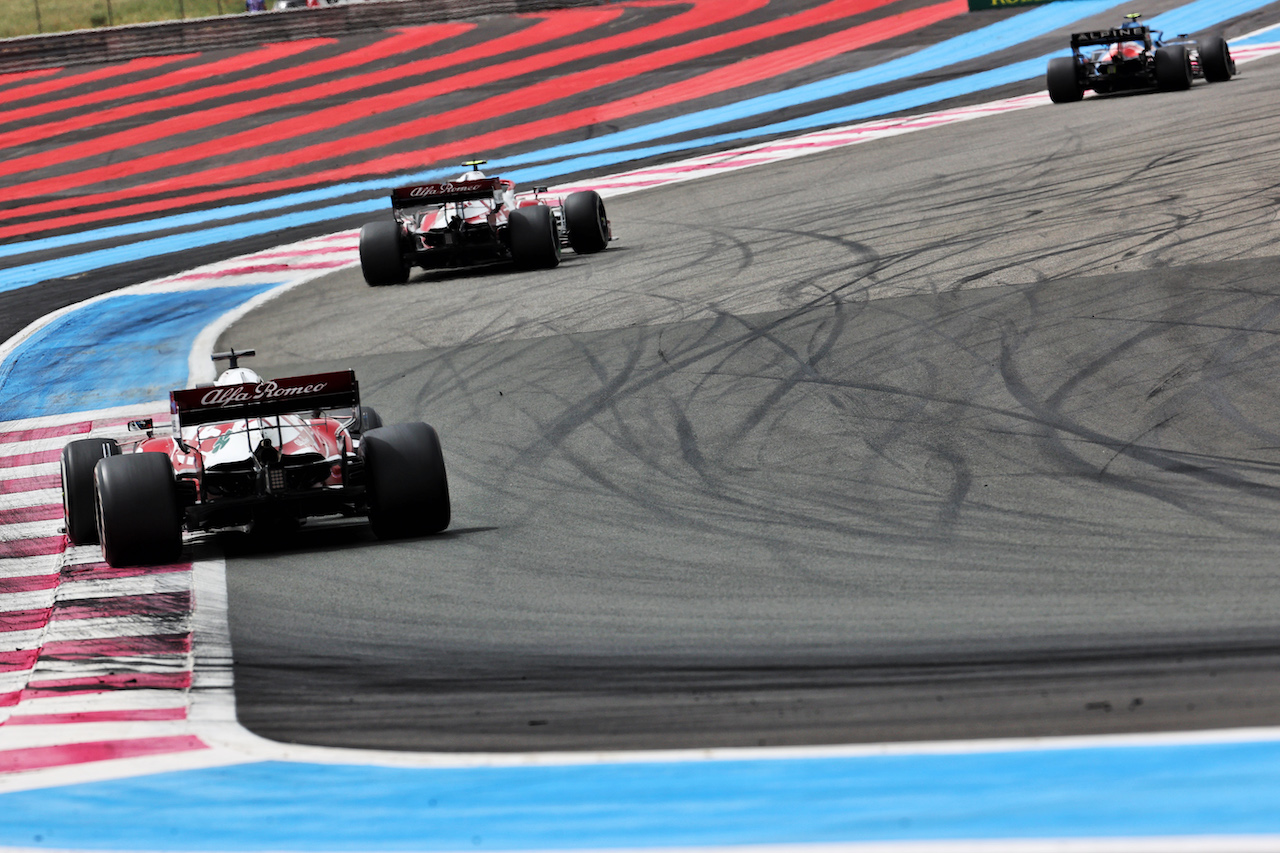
xmin=169 ymin=370 xmax=360 ymax=429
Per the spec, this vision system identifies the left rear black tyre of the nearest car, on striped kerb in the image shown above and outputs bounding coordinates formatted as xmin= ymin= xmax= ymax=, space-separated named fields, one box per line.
xmin=93 ymin=453 xmax=182 ymax=566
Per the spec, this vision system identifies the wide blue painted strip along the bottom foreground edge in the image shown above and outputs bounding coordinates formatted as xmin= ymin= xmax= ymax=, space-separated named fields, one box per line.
xmin=0 ymin=743 xmax=1280 ymax=852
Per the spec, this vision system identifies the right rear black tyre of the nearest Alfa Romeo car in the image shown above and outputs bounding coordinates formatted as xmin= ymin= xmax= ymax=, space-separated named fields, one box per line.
xmin=360 ymin=423 xmax=449 ymax=539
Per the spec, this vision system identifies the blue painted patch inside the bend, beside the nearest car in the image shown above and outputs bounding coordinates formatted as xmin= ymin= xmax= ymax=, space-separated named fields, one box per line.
xmin=0 ymin=283 xmax=279 ymax=420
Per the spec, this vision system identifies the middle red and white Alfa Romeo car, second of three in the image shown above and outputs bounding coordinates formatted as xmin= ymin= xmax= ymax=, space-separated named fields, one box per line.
xmin=360 ymin=160 xmax=613 ymax=287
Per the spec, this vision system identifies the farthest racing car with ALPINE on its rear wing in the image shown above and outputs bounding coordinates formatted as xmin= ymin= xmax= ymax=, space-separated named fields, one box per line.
xmin=1047 ymin=14 xmax=1235 ymax=104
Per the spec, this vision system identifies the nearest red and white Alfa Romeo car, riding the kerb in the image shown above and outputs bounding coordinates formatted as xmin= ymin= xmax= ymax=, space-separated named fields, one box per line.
xmin=61 ymin=350 xmax=449 ymax=566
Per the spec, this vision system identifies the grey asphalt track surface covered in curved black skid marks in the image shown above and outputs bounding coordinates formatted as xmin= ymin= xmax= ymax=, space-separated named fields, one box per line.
xmin=215 ymin=49 xmax=1280 ymax=751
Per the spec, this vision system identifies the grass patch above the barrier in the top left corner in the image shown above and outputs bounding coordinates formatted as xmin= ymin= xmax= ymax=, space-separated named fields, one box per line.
xmin=0 ymin=0 xmax=235 ymax=38
